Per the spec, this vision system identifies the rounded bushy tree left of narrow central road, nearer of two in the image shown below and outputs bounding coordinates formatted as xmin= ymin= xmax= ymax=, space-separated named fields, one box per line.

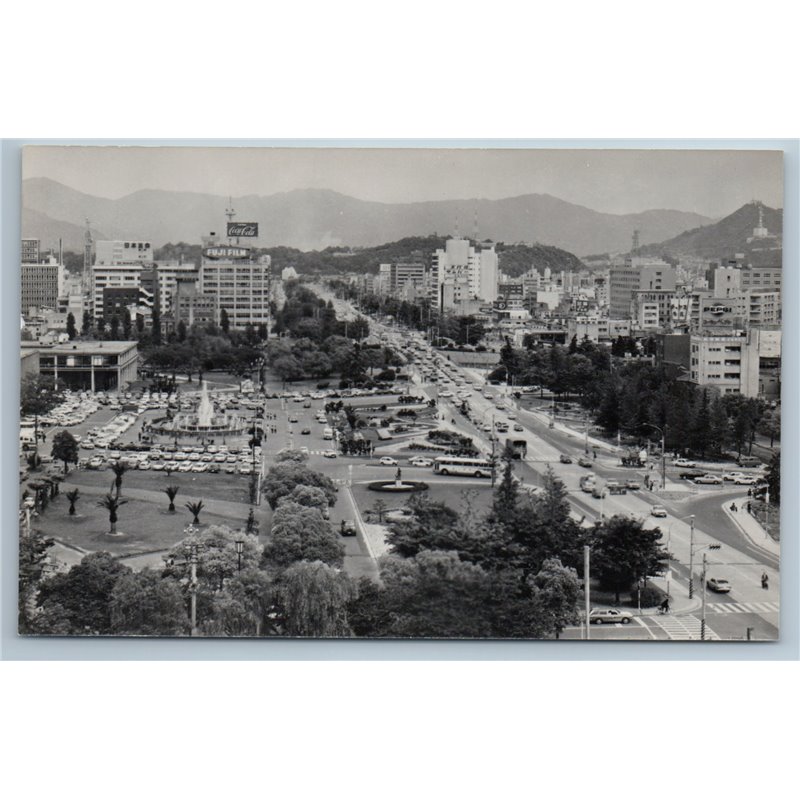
xmin=263 ymin=498 xmax=344 ymax=568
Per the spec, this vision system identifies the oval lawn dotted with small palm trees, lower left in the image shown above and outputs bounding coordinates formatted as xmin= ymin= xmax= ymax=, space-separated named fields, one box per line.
xmin=34 ymin=490 xmax=247 ymax=556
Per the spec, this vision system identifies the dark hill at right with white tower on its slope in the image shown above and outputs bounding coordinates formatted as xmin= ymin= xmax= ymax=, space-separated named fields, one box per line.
xmin=638 ymin=203 xmax=783 ymax=264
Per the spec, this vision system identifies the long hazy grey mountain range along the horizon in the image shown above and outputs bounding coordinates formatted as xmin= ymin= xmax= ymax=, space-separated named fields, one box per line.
xmin=22 ymin=178 xmax=713 ymax=255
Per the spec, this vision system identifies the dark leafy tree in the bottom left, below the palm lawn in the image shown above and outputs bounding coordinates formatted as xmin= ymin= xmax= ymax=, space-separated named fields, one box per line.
xmin=38 ymin=552 xmax=131 ymax=635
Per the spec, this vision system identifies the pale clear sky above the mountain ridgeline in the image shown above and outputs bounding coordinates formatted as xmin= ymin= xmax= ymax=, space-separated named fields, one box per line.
xmin=22 ymin=145 xmax=783 ymax=218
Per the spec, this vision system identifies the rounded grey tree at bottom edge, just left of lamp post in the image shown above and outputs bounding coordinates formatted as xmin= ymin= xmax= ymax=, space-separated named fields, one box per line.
xmin=109 ymin=567 xmax=189 ymax=636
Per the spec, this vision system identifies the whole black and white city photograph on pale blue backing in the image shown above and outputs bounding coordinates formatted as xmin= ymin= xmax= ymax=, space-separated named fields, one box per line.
xmin=17 ymin=145 xmax=784 ymax=640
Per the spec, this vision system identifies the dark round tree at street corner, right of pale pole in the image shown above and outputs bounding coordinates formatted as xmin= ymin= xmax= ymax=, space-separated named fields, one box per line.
xmin=592 ymin=516 xmax=668 ymax=602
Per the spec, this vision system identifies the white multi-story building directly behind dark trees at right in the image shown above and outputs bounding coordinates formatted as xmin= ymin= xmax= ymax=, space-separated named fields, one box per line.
xmin=689 ymin=332 xmax=759 ymax=397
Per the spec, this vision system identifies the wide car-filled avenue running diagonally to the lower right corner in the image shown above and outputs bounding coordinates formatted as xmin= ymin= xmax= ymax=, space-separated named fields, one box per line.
xmin=328 ymin=301 xmax=780 ymax=639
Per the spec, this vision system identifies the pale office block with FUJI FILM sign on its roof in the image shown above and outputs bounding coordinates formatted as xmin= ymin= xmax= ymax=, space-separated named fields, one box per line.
xmin=200 ymin=235 xmax=272 ymax=329
